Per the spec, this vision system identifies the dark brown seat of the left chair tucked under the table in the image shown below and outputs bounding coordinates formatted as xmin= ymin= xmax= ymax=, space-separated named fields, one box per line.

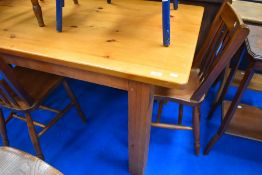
xmin=0 ymin=66 xmax=63 ymax=109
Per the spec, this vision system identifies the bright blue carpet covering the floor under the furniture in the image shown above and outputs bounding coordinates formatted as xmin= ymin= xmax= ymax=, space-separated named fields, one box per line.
xmin=0 ymin=80 xmax=262 ymax=175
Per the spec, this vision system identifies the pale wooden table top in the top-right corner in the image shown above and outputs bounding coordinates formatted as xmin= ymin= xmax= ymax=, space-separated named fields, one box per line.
xmin=232 ymin=0 xmax=262 ymax=24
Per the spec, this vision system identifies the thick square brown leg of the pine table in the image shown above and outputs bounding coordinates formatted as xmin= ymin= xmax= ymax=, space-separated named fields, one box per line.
xmin=128 ymin=81 xmax=154 ymax=175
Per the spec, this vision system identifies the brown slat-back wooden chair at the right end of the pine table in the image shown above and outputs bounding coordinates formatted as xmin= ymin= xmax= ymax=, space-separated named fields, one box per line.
xmin=152 ymin=3 xmax=249 ymax=155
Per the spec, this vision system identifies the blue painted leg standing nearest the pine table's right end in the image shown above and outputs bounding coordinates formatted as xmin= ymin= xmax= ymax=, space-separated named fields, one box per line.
xmin=162 ymin=0 xmax=170 ymax=47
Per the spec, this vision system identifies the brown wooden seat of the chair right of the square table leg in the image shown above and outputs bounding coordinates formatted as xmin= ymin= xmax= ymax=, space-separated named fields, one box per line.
xmin=155 ymin=69 xmax=204 ymax=105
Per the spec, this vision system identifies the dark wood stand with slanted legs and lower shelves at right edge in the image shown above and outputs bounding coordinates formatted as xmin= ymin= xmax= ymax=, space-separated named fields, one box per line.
xmin=204 ymin=24 xmax=262 ymax=155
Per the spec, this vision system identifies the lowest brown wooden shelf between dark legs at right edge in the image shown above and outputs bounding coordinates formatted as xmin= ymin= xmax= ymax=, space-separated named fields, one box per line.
xmin=223 ymin=101 xmax=262 ymax=141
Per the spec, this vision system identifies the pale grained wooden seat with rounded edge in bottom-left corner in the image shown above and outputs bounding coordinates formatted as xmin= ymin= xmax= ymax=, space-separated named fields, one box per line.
xmin=0 ymin=147 xmax=63 ymax=175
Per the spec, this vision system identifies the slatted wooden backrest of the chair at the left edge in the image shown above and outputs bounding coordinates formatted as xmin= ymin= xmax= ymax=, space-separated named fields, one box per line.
xmin=0 ymin=57 xmax=33 ymax=109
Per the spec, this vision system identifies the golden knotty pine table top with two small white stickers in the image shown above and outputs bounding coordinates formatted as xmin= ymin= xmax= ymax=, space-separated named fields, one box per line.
xmin=0 ymin=0 xmax=204 ymax=87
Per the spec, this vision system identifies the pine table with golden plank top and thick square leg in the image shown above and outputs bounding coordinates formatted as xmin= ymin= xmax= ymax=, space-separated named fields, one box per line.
xmin=0 ymin=0 xmax=203 ymax=174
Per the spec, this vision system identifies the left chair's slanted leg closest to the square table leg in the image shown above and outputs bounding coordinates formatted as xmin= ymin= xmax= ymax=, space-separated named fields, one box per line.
xmin=63 ymin=80 xmax=87 ymax=122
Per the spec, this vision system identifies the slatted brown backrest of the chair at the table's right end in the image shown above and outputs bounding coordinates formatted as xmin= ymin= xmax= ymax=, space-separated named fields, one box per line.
xmin=191 ymin=2 xmax=249 ymax=101
